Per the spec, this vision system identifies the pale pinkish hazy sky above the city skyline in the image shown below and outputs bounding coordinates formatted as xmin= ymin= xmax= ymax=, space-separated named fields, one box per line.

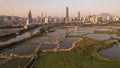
xmin=0 ymin=0 xmax=120 ymax=17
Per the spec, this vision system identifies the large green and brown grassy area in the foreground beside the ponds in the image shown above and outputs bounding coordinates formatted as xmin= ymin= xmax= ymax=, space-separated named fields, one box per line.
xmin=35 ymin=38 xmax=120 ymax=68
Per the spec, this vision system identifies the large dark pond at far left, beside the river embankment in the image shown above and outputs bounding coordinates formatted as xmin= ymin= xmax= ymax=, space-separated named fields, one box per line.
xmin=0 ymin=43 xmax=39 ymax=55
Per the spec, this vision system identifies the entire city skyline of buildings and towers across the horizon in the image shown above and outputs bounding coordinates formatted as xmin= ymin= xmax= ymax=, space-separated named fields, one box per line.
xmin=0 ymin=7 xmax=120 ymax=27
